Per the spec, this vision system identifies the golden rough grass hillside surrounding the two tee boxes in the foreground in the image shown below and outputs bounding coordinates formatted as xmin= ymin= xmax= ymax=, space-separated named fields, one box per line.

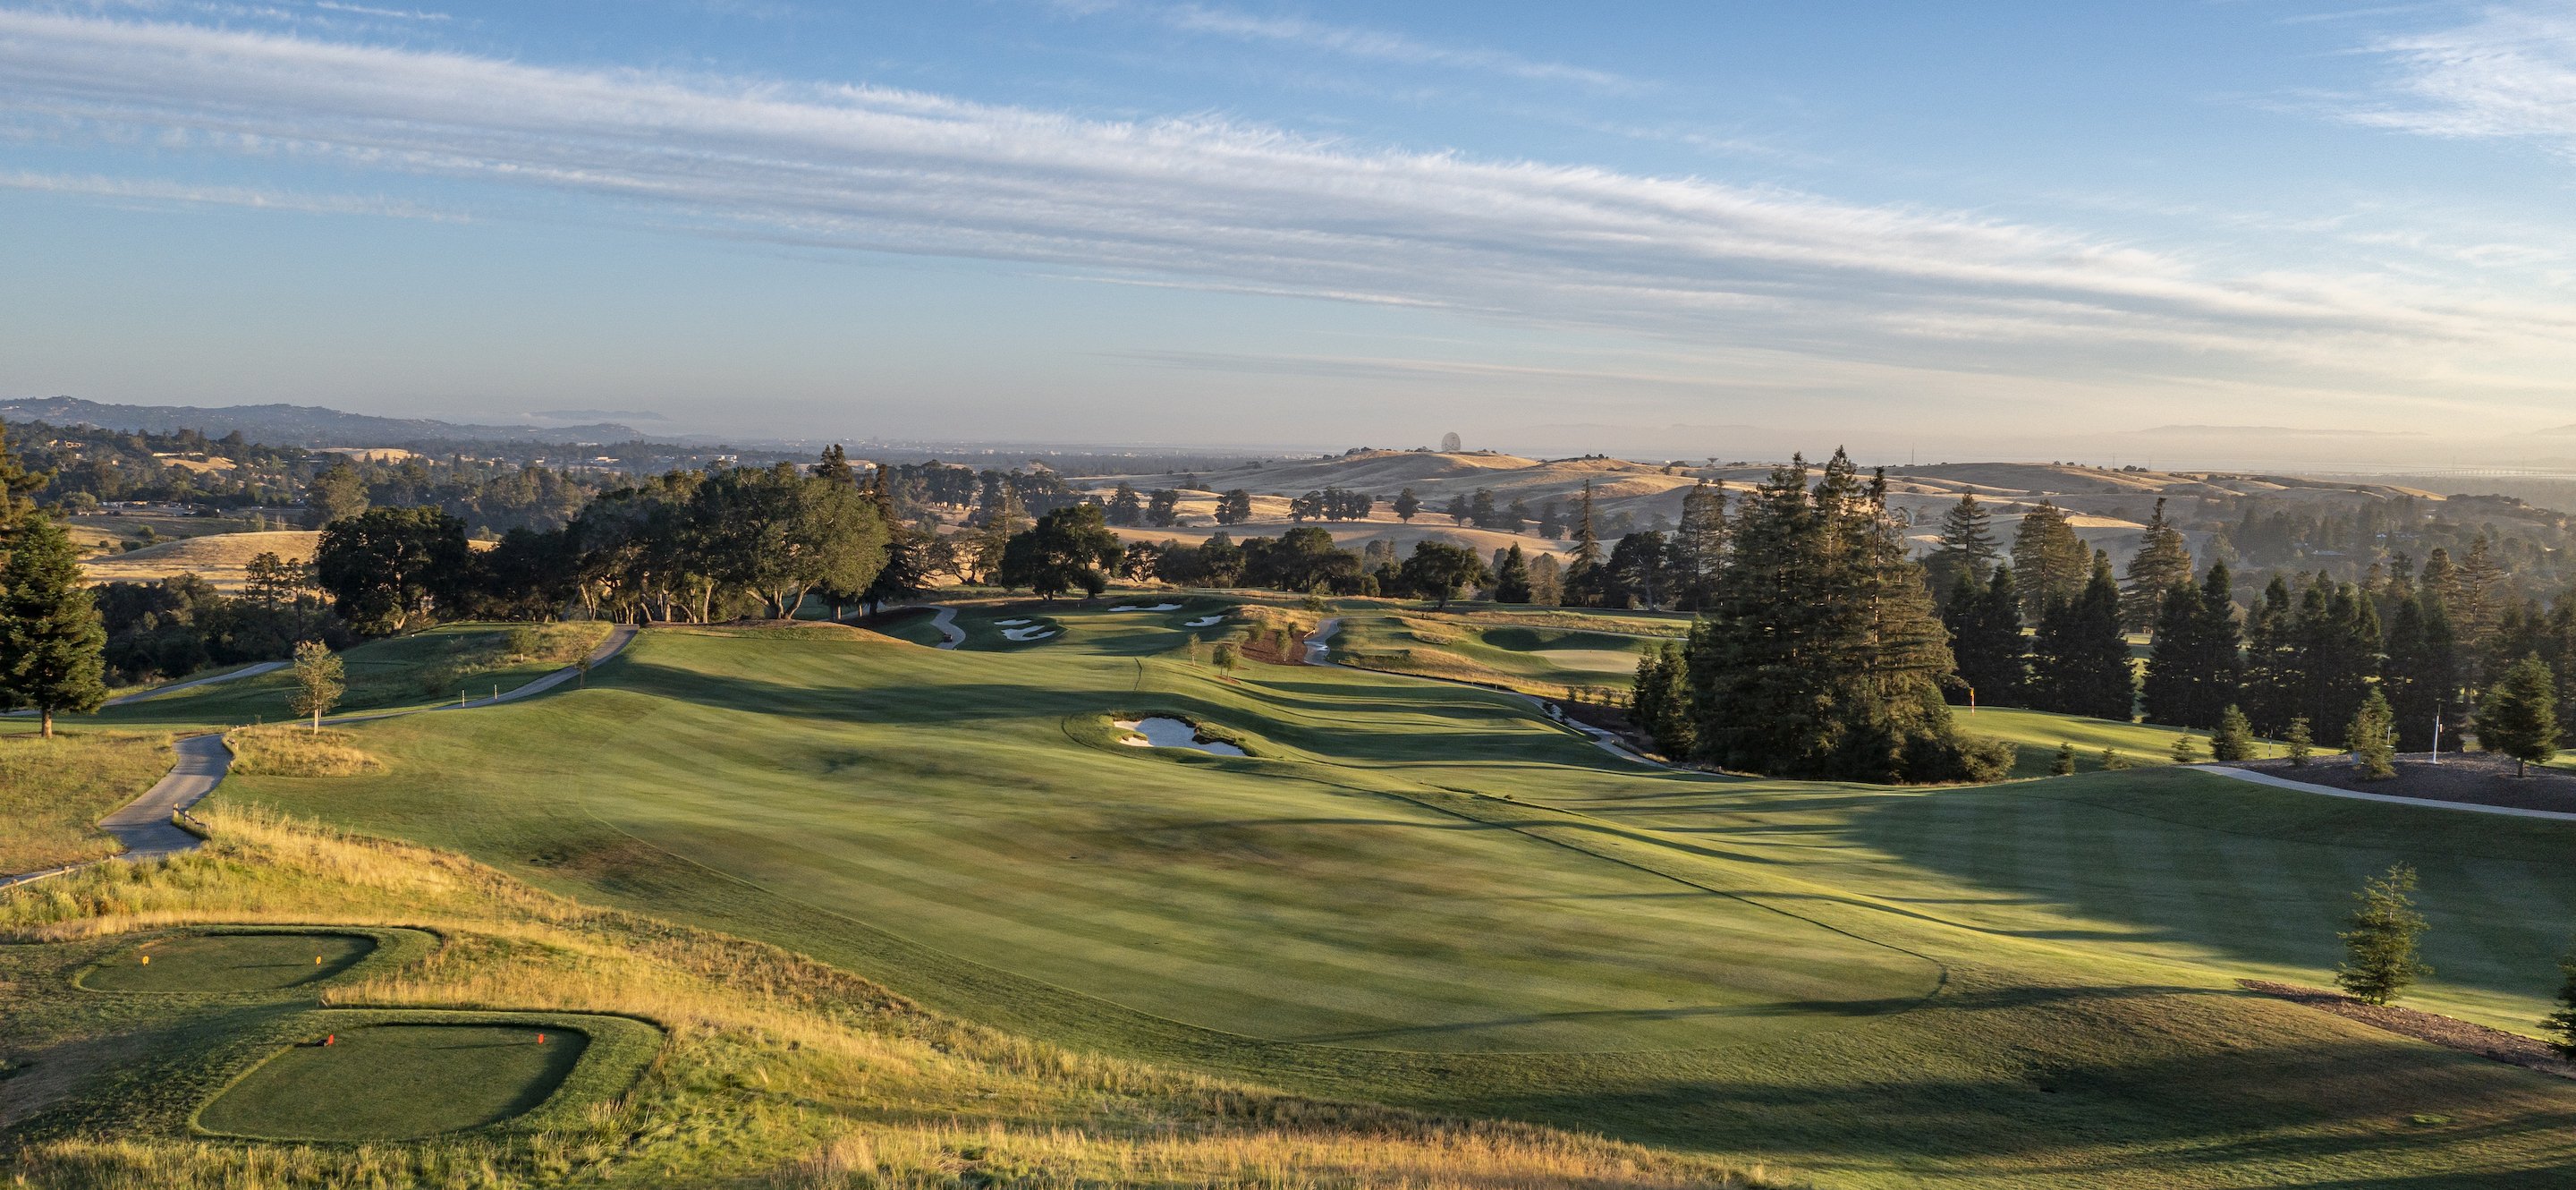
xmin=0 ymin=806 xmax=1757 ymax=1190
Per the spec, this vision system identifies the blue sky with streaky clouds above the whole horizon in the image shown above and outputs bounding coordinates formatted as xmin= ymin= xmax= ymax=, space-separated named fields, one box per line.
xmin=0 ymin=0 xmax=2576 ymax=463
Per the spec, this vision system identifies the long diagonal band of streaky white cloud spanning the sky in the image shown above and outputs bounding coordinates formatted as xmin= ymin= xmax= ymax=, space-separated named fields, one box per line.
xmin=0 ymin=11 xmax=2576 ymax=414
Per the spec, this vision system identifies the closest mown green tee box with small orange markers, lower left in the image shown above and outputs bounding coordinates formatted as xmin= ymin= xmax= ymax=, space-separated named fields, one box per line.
xmin=196 ymin=1023 xmax=590 ymax=1141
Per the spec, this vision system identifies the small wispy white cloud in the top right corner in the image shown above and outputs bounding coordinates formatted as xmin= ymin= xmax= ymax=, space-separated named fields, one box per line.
xmin=2344 ymin=3 xmax=2576 ymax=155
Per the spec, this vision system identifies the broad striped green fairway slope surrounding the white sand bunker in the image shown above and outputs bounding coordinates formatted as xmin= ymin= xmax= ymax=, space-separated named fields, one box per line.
xmin=206 ymin=608 xmax=2576 ymax=1187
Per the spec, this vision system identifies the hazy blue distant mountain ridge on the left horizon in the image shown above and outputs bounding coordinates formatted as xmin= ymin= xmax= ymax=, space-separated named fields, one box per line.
xmin=0 ymin=396 xmax=667 ymax=446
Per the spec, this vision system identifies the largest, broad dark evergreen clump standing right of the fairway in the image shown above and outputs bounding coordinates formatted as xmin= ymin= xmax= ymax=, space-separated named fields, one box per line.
xmin=1687 ymin=451 xmax=2009 ymax=780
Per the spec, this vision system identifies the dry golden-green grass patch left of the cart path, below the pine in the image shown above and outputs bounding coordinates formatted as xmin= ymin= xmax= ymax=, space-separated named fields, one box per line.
xmin=0 ymin=721 xmax=170 ymax=876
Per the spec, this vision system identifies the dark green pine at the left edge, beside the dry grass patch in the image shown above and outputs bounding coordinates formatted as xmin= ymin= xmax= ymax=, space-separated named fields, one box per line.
xmin=0 ymin=513 xmax=108 ymax=739
